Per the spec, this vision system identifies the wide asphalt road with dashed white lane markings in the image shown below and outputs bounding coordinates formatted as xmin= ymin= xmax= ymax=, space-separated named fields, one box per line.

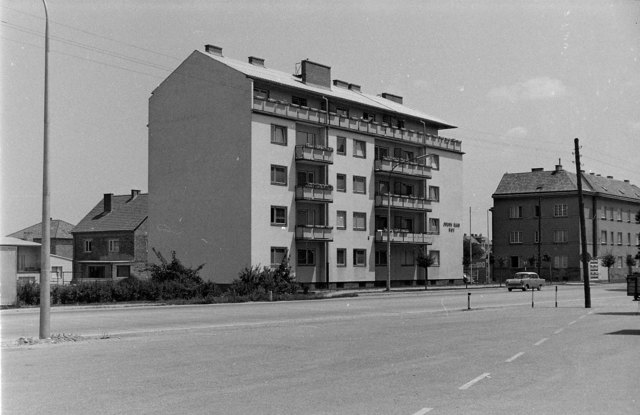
xmin=0 ymin=285 xmax=640 ymax=415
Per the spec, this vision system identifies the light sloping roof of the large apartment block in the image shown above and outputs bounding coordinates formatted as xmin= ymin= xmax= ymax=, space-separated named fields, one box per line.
xmin=196 ymin=51 xmax=456 ymax=129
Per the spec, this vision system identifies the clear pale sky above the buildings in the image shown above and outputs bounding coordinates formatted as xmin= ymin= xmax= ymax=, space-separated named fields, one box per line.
xmin=0 ymin=0 xmax=640 ymax=235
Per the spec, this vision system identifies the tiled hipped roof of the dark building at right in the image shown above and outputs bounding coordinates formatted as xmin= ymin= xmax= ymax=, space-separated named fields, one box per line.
xmin=493 ymin=170 xmax=640 ymax=202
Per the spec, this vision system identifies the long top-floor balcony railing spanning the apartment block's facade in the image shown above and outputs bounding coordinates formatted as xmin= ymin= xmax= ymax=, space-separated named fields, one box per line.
xmin=253 ymin=97 xmax=462 ymax=152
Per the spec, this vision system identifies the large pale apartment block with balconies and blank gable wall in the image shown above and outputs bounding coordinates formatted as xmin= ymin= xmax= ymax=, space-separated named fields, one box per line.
xmin=149 ymin=45 xmax=463 ymax=288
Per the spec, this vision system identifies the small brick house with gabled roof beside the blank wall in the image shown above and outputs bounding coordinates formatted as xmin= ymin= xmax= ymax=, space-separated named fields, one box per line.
xmin=71 ymin=190 xmax=148 ymax=282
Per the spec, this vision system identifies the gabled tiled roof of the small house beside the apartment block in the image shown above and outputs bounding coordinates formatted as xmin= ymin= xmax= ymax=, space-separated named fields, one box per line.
xmin=71 ymin=193 xmax=149 ymax=233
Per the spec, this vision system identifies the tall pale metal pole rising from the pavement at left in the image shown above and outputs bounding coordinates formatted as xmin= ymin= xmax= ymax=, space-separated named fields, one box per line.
xmin=40 ymin=0 xmax=51 ymax=339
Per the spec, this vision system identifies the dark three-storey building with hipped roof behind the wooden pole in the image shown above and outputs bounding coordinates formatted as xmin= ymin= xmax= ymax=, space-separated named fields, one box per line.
xmin=493 ymin=165 xmax=640 ymax=281
